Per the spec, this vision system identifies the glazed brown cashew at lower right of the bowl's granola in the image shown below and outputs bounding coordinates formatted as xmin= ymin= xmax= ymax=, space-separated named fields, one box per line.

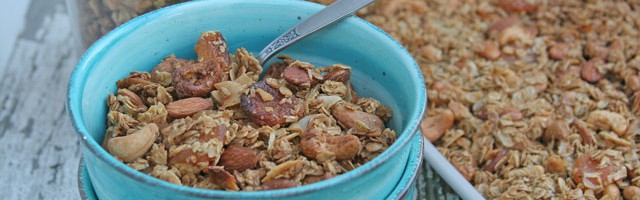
xmin=300 ymin=129 xmax=362 ymax=162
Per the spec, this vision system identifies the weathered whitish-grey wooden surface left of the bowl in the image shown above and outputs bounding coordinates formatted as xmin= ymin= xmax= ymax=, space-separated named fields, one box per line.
xmin=0 ymin=0 xmax=80 ymax=199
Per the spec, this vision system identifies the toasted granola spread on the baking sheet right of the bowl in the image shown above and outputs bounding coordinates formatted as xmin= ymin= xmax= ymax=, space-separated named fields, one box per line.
xmin=312 ymin=0 xmax=640 ymax=199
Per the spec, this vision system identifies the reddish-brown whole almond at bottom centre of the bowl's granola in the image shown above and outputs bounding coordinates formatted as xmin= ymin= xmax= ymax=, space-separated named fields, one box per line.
xmin=220 ymin=146 xmax=258 ymax=172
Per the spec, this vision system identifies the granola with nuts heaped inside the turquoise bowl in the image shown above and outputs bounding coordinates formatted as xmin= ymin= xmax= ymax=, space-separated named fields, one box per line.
xmin=103 ymin=31 xmax=396 ymax=191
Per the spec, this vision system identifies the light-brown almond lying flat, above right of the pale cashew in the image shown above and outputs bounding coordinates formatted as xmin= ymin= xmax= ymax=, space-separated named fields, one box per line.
xmin=167 ymin=97 xmax=213 ymax=118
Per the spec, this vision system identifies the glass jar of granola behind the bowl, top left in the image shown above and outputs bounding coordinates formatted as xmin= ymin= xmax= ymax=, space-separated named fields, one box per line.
xmin=67 ymin=0 xmax=188 ymax=50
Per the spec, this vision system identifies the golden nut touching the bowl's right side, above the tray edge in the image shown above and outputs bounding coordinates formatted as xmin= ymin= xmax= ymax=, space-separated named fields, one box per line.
xmin=420 ymin=109 xmax=453 ymax=142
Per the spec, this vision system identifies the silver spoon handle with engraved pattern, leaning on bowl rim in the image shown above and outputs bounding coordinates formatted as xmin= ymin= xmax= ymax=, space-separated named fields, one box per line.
xmin=258 ymin=0 xmax=375 ymax=65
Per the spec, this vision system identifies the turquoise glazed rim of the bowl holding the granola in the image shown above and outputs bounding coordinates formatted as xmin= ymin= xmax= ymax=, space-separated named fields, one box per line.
xmin=65 ymin=0 xmax=427 ymax=198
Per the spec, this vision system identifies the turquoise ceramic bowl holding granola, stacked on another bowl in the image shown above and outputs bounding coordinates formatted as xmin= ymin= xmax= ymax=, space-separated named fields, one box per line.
xmin=67 ymin=0 xmax=426 ymax=199
